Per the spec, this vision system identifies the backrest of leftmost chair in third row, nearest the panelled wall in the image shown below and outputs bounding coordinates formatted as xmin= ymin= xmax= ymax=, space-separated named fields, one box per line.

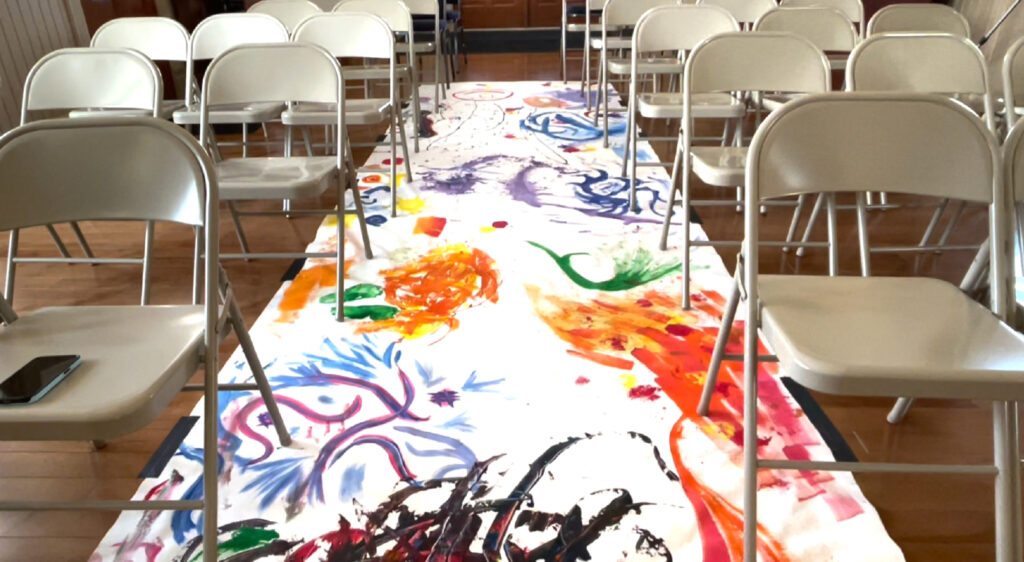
xmin=90 ymin=17 xmax=189 ymax=61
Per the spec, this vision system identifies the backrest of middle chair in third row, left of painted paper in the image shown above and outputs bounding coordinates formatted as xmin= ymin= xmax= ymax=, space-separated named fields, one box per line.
xmin=191 ymin=13 xmax=289 ymax=60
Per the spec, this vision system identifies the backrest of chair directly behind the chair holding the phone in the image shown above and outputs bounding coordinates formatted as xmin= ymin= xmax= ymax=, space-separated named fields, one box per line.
xmin=22 ymin=47 xmax=163 ymax=124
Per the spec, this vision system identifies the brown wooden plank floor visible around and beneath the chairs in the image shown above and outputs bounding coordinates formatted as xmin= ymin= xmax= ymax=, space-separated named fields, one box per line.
xmin=0 ymin=53 xmax=1015 ymax=562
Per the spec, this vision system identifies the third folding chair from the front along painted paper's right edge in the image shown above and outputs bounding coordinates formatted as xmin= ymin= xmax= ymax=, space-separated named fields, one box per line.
xmin=622 ymin=4 xmax=745 ymax=204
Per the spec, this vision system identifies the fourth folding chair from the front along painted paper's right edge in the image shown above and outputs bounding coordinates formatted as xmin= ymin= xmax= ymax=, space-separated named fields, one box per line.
xmin=592 ymin=0 xmax=682 ymax=147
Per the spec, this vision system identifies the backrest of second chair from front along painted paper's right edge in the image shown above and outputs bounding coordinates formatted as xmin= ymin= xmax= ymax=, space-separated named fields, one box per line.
xmin=683 ymin=32 xmax=831 ymax=94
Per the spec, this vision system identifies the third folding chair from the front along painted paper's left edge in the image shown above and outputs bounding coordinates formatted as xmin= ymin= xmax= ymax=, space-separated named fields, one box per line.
xmin=281 ymin=12 xmax=412 ymax=217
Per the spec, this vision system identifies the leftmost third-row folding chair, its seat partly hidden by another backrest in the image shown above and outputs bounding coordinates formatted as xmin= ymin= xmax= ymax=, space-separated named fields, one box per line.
xmin=70 ymin=17 xmax=190 ymax=119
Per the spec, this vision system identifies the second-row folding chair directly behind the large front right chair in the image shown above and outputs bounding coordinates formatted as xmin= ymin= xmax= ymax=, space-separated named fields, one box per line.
xmin=797 ymin=33 xmax=995 ymax=261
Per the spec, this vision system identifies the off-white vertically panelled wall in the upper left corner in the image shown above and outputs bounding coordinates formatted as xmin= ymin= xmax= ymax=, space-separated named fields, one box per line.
xmin=0 ymin=0 xmax=89 ymax=132
